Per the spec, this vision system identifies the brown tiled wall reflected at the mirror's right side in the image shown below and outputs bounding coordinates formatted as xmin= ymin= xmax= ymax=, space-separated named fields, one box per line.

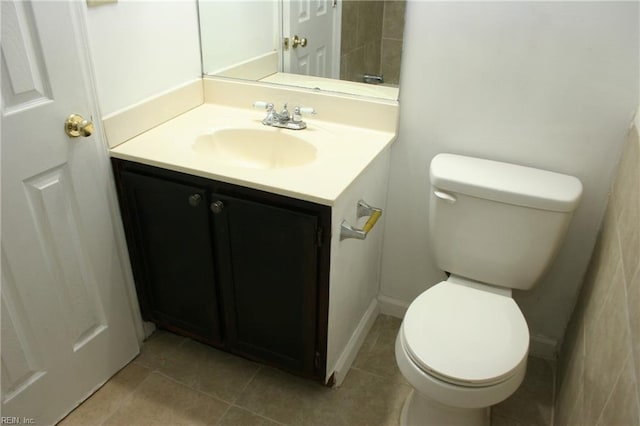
xmin=340 ymin=0 xmax=405 ymax=84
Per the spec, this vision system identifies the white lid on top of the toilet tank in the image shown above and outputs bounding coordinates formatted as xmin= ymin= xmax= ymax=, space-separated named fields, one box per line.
xmin=430 ymin=154 xmax=582 ymax=212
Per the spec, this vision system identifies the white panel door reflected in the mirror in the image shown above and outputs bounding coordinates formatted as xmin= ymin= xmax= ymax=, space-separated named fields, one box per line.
xmin=283 ymin=0 xmax=341 ymax=78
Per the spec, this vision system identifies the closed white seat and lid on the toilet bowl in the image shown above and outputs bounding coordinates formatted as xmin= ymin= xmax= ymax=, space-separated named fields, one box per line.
xmin=401 ymin=277 xmax=529 ymax=387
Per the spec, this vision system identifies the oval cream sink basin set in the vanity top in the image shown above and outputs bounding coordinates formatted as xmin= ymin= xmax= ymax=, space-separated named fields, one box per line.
xmin=193 ymin=128 xmax=317 ymax=169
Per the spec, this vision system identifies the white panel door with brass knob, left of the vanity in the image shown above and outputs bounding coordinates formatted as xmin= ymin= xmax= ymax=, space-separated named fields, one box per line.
xmin=0 ymin=0 xmax=139 ymax=425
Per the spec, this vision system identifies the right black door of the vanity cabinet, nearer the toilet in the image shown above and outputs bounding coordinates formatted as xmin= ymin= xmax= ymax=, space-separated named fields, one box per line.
xmin=212 ymin=194 xmax=322 ymax=377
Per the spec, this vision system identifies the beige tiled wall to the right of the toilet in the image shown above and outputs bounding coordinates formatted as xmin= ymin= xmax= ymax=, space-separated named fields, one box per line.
xmin=554 ymin=127 xmax=640 ymax=426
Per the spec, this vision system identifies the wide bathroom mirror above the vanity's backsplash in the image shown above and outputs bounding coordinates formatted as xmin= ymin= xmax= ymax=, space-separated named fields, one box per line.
xmin=198 ymin=0 xmax=406 ymax=100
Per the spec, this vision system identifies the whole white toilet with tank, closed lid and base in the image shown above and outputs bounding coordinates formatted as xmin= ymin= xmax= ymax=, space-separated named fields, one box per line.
xmin=395 ymin=154 xmax=582 ymax=426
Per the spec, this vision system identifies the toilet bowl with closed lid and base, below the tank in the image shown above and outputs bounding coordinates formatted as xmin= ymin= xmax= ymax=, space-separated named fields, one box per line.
xmin=395 ymin=276 xmax=529 ymax=426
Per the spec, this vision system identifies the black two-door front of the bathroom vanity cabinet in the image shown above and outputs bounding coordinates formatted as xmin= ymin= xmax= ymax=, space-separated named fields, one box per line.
xmin=112 ymin=158 xmax=331 ymax=381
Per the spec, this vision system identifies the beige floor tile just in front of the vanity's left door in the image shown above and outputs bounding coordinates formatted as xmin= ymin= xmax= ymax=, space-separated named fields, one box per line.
xmin=158 ymin=340 xmax=259 ymax=403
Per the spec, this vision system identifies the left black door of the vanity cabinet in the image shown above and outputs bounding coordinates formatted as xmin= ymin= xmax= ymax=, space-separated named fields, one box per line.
xmin=121 ymin=171 xmax=221 ymax=344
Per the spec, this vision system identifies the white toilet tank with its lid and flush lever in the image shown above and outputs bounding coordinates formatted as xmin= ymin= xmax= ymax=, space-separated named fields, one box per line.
xmin=429 ymin=154 xmax=582 ymax=290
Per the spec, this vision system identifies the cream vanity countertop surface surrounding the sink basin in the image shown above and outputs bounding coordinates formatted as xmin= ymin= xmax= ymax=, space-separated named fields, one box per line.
xmin=110 ymin=104 xmax=396 ymax=205
